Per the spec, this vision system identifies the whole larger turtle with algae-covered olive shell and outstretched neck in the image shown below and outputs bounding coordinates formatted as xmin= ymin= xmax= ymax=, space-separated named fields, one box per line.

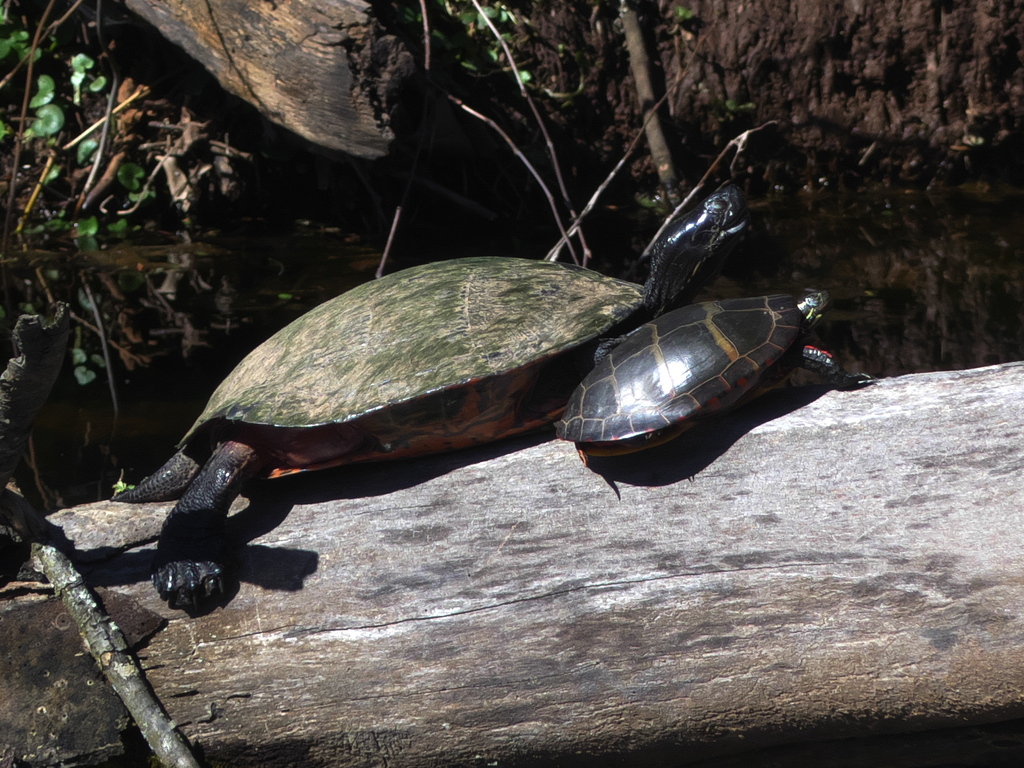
xmin=114 ymin=186 xmax=750 ymax=609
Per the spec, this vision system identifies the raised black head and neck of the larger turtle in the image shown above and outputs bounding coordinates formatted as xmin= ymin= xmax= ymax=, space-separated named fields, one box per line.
xmin=643 ymin=184 xmax=751 ymax=317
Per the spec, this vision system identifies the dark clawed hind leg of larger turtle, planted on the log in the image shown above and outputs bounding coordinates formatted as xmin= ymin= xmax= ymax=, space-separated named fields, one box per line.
xmin=153 ymin=441 xmax=262 ymax=609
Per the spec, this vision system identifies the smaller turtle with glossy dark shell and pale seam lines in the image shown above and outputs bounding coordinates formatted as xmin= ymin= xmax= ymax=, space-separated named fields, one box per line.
xmin=555 ymin=292 xmax=871 ymax=457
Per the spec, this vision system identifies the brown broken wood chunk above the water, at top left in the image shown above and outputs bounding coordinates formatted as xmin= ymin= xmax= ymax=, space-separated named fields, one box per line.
xmin=124 ymin=0 xmax=415 ymax=159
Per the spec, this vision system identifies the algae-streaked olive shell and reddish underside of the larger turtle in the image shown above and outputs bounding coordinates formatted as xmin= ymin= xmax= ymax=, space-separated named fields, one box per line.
xmin=181 ymin=258 xmax=642 ymax=475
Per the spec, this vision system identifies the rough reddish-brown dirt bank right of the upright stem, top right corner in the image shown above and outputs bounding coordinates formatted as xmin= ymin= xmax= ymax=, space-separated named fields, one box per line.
xmin=658 ymin=0 xmax=1024 ymax=183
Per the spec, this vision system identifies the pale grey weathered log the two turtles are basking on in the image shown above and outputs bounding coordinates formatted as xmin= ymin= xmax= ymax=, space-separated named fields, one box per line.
xmin=53 ymin=364 xmax=1024 ymax=766
